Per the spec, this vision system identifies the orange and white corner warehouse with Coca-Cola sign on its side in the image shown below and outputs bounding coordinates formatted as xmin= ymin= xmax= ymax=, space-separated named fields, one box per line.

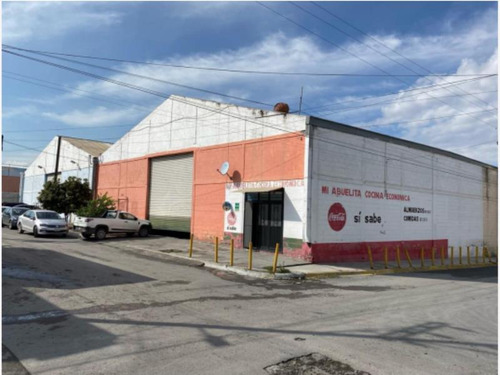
xmin=98 ymin=96 xmax=498 ymax=263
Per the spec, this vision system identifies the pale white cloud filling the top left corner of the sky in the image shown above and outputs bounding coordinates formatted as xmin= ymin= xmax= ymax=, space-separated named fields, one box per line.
xmin=2 ymin=1 xmax=121 ymax=43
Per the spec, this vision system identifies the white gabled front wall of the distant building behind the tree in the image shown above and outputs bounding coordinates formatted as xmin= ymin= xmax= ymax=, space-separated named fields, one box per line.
xmin=21 ymin=137 xmax=93 ymax=204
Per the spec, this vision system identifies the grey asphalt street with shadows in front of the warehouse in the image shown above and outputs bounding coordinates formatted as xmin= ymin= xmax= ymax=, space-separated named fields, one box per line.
xmin=2 ymin=229 xmax=498 ymax=375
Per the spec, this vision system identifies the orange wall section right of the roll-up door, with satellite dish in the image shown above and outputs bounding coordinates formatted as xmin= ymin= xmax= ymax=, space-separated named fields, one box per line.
xmin=192 ymin=134 xmax=305 ymax=239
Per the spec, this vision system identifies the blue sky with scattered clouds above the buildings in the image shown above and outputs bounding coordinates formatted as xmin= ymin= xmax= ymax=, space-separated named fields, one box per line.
xmin=2 ymin=1 xmax=498 ymax=165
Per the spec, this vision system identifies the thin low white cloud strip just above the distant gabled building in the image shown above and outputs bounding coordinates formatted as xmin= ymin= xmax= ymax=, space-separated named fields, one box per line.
xmin=42 ymin=106 xmax=138 ymax=126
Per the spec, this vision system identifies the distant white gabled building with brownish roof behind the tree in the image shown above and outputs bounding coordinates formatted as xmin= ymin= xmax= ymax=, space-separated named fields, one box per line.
xmin=21 ymin=136 xmax=111 ymax=204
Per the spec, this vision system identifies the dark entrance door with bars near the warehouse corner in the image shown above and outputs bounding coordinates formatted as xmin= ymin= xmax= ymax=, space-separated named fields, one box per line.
xmin=243 ymin=189 xmax=284 ymax=250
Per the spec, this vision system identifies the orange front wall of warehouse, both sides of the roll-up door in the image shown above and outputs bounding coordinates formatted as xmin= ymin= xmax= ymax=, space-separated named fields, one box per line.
xmin=97 ymin=133 xmax=305 ymax=239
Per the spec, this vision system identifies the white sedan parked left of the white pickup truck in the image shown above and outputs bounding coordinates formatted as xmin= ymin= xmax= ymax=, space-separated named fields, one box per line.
xmin=17 ymin=210 xmax=68 ymax=237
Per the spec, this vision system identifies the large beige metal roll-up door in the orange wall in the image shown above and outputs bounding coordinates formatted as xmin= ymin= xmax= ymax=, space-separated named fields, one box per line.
xmin=149 ymin=154 xmax=193 ymax=233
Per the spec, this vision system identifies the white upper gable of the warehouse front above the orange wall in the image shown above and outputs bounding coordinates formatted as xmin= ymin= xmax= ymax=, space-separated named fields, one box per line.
xmin=100 ymin=96 xmax=306 ymax=163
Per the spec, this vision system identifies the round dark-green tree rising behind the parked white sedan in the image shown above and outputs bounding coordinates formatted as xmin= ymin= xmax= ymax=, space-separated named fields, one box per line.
xmin=38 ymin=177 xmax=92 ymax=214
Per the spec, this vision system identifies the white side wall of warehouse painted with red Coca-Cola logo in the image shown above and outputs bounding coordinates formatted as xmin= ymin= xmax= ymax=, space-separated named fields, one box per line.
xmin=311 ymin=128 xmax=483 ymax=250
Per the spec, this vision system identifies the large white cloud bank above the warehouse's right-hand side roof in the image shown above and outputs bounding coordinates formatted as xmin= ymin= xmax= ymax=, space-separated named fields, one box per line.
xmin=362 ymin=51 xmax=498 ymax=164
